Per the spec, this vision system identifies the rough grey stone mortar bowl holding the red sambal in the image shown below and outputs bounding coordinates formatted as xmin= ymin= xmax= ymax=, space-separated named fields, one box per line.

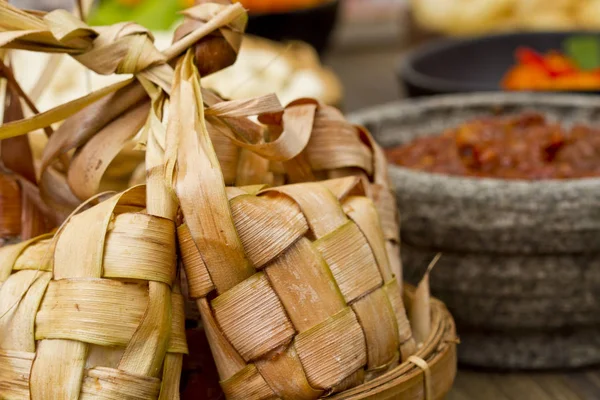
xmin=351 ymin=92 xmax=600 ymax=369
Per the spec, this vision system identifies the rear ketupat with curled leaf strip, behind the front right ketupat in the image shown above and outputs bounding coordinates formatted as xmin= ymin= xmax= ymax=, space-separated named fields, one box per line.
xmin=99 ymin=90 xmax=402 ymax=290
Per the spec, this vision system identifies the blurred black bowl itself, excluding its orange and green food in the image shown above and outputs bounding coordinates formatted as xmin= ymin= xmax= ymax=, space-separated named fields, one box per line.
xmin=398 ymin=31 xmax=600 ymax=97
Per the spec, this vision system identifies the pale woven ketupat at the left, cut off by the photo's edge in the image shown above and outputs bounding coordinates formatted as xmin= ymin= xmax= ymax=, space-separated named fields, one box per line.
xmin=0 ymin=186 xmax=187 ymax=400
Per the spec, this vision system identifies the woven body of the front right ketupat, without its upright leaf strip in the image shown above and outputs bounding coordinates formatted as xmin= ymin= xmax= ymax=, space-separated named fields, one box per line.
xmin=178 ymin=177 xmax=415 ymax=399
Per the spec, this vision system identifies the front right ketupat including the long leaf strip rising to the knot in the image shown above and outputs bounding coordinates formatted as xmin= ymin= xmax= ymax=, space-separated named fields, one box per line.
xmin=171 ymin=53 xmax=415 ymax=399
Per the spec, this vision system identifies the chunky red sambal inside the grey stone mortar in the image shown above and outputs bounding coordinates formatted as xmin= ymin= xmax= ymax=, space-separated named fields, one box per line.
xmin=386 ymin=113 xmax=600 ymax=180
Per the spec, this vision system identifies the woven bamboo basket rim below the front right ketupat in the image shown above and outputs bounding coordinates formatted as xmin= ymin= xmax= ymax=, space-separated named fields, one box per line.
xmin=331 ymin=284 xmax=458 ymax=400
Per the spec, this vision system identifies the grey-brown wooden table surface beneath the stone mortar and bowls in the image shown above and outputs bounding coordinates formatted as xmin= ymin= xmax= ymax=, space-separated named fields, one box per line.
xmin=325 ymin=45 xmax=600 ymax=400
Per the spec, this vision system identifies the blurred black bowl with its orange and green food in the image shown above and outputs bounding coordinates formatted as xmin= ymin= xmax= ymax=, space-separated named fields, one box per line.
xmin=398 ymin=31 xmax=600 ymax=97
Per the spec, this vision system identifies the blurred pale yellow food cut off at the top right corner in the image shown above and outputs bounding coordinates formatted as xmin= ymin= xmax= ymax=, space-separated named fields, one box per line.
xmin=411 ymin=0 xmax=600 ymax=35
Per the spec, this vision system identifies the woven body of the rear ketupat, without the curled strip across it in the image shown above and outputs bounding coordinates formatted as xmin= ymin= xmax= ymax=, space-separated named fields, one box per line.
xmin=208 ymin=99 xmax=402 ymax=285
